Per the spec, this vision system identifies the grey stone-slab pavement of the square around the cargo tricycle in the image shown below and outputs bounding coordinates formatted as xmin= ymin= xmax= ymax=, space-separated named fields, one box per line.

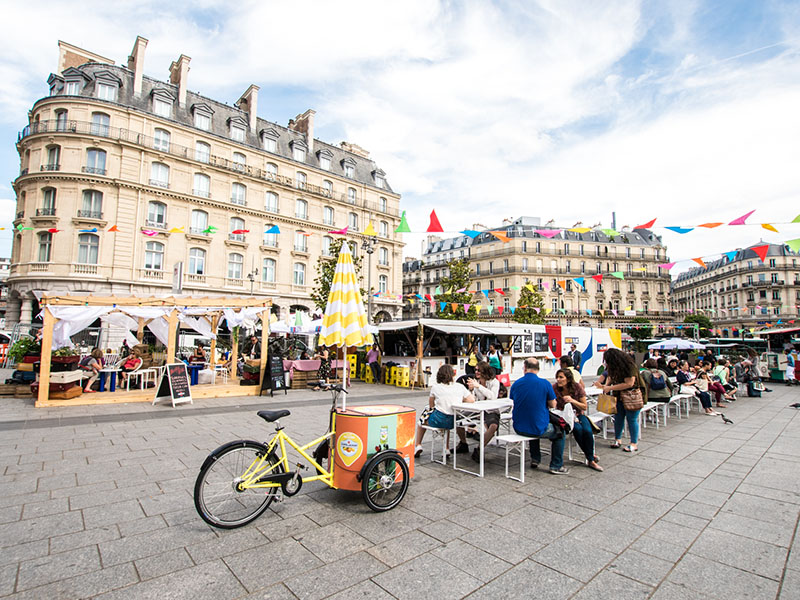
xmin=0 ymin=384 xmax=800 ymax=600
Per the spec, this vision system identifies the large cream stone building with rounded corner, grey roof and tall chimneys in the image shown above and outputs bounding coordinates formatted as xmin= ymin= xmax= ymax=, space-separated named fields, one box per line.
xmin=8 ymin=38 xmax=403 ymax=323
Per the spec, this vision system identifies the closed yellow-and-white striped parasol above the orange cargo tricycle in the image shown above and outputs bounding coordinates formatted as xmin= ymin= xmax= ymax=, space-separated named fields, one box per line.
xmin=319 ymin=244 xmax=373 ymax=348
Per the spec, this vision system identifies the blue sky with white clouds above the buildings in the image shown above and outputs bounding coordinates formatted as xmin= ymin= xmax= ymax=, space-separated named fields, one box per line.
xmin=0 ymin=0 xmax=800 ymax=269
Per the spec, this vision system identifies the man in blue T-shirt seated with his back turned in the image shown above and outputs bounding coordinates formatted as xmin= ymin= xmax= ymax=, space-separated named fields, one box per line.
xmin=510 ymin=358 xmax=569 ymax=475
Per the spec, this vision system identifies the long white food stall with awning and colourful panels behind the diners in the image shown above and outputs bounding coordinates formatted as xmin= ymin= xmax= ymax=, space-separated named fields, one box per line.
xmin=378 ymin=318 xmax=622 ymax=385
